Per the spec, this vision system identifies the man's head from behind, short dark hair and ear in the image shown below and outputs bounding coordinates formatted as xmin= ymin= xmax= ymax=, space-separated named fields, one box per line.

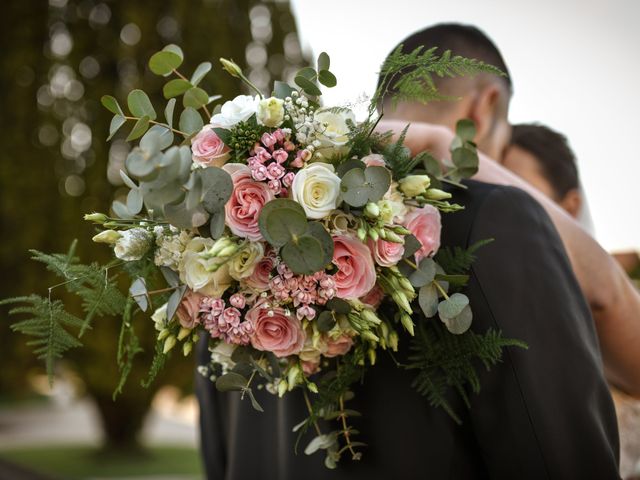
xmin=379 ymin=23 xmax=512 ymax=158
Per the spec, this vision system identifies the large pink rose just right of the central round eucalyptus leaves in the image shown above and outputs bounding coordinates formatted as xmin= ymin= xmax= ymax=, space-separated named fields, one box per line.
xmin=333 ymin=235 xmax=376 ymax=298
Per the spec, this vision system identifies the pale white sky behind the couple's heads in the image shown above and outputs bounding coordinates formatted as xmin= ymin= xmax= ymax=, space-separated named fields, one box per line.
xmin=292 ymin=0 xmax=640 ymax=251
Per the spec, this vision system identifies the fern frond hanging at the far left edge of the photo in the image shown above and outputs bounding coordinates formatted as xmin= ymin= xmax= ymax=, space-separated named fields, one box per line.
xmin=0 ymin=295 xmax=83 ymax=384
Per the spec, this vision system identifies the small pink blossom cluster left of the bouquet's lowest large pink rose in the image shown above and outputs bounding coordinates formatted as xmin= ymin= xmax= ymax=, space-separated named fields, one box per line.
xmin=200 ymin=294 xmax=253 ymax=345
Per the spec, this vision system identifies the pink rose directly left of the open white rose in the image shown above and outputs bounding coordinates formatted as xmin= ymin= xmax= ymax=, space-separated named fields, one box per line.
xmin=223 ymin=163 xmax=275 ymax=242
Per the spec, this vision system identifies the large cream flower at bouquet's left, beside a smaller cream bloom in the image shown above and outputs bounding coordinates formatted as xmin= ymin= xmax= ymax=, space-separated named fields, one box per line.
xmin=178 ymin=237 xmax=231 ymax=297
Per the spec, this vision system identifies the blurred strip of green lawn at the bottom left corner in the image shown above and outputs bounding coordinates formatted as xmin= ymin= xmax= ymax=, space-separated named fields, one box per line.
xmin=0 ymin=446 xmax=203 ymax=480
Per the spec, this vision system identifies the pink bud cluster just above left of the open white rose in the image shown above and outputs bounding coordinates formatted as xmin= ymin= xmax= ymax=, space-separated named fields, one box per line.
xmin=247 ymin=128 xmax=296 ymax=195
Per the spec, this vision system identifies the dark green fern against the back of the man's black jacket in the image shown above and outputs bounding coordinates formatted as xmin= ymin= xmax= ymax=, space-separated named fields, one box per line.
xmin=406 ymin=320 xmax=527 ymax=423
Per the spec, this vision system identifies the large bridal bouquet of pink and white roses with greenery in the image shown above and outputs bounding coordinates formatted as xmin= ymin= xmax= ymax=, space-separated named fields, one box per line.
xmin=6 ymin=45 xmax=524 ymax=467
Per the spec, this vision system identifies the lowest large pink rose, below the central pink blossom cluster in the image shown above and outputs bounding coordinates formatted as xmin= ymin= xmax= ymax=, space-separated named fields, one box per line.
xmin=245 ymin=302 xmax=305 ymax=357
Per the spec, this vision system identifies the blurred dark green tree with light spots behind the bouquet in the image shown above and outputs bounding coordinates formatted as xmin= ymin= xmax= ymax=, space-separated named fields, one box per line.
xmin=0 ymin=0 xmax=305 ymax=472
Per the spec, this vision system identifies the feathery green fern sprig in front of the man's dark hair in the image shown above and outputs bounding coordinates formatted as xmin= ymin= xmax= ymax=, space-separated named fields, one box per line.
xmin=371 ymin=45 xmax=504 ymax=111
